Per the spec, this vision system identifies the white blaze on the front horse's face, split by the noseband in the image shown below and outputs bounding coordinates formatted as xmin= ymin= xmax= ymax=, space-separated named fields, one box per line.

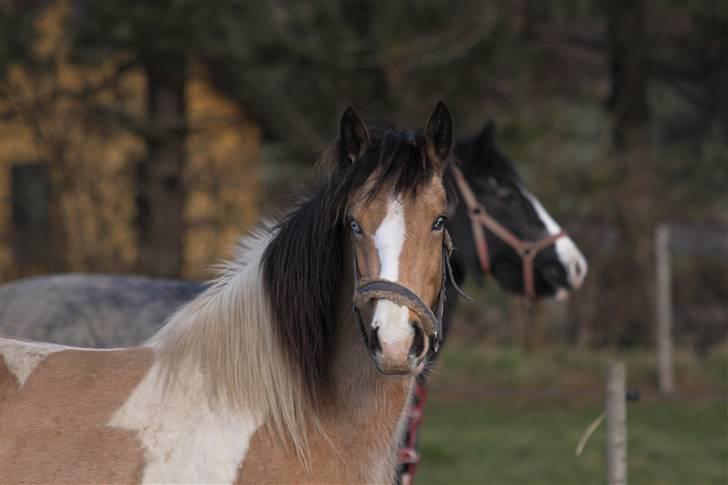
xmin=372 ymin=197 xmax=414 ymax=345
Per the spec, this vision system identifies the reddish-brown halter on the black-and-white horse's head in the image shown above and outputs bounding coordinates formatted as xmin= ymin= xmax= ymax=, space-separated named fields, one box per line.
xmin=451 ymin=165 xmax=566 ymax=300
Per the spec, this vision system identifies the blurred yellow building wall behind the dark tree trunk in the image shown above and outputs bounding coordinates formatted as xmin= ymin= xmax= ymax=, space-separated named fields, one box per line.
xmin=0 ymin=2 xmax=260 ymax=281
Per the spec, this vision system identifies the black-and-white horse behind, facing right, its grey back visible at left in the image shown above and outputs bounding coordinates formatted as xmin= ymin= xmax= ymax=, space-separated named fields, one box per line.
xmin=0 ymin=115 xmax=587 ymax=482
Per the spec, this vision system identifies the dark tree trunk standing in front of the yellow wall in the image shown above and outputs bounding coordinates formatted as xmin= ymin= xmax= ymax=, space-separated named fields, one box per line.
xmin=136 ymin=69 xmax=186 ymax=277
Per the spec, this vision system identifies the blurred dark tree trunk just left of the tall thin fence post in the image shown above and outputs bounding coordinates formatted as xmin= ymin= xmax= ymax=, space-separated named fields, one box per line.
xmin=607 ymin=0 xmax=656 ymax=344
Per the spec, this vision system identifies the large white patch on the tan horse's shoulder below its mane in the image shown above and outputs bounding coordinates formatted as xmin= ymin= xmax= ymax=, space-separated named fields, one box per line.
xmin=109 ymin=364 xmax=259 ymax=483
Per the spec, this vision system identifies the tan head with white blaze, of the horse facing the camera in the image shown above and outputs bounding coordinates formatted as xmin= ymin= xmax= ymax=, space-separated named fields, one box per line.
xmin=338 ymin=103 xmax=452 ymax=375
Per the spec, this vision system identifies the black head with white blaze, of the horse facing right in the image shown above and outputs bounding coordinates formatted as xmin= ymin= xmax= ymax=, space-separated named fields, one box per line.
xmin=452 ymin=121 xmax=587 ymax=297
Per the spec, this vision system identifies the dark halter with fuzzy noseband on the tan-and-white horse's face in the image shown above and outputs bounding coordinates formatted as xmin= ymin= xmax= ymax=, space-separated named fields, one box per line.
xmin=353 ymin=230 xmax=468 ymax=355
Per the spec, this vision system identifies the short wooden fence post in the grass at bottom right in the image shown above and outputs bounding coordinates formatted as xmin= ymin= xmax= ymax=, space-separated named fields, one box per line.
xmin=606 ymin=362 xmax=627 ymax=485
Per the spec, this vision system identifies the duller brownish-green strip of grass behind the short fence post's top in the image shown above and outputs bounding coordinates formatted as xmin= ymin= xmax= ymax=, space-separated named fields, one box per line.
xmin=432 ymin=339 xmax=728 ymax=403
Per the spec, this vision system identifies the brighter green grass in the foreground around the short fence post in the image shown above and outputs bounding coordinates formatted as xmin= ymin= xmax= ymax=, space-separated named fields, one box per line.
xmin=417 ymin=399 xmax=728 ymax=485
